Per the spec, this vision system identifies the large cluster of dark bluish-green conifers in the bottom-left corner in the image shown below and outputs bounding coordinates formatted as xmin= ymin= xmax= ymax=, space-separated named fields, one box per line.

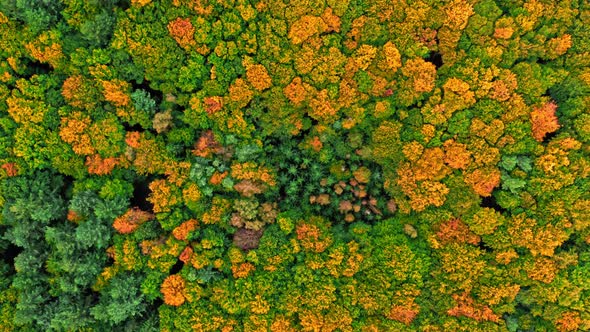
xmin=2 ymin=171 xmax=160 ymax=330
